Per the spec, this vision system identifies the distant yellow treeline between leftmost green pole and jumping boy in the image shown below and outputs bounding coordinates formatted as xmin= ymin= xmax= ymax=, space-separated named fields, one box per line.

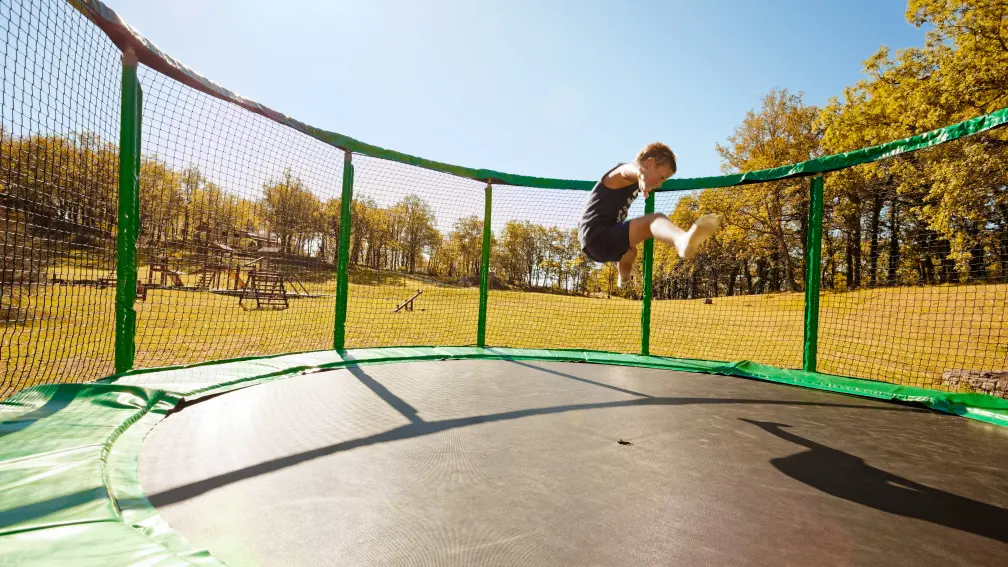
xmin=140 ymin=160 xmax=612 ymax=293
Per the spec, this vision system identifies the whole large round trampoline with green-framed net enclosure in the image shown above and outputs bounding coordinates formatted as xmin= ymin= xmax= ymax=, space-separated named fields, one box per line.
xmin=0 ymin=0 xmax=1008 ymax=567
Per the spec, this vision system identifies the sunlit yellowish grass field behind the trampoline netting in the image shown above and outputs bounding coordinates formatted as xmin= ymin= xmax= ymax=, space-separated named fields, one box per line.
xmin=0 ymin=264 xmax=1008 ymax=398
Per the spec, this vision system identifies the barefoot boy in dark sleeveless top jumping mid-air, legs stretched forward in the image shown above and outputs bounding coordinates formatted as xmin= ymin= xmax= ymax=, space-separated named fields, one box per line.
xmin=578 ymin=142 xmax=721 ymax=288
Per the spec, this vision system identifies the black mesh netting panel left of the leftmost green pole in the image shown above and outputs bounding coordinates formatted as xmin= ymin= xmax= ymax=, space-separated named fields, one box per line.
xmin=0 ymin=1 xmax=121 ymax=399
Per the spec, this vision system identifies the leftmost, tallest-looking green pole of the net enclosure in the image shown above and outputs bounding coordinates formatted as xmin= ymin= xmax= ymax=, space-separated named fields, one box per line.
xmin=115 ymin=49 xmax=141 ymax=373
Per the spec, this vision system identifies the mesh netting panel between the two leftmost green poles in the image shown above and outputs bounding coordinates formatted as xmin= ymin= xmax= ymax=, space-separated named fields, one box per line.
xmin=136 ymin=68 xmax=344 ymax=366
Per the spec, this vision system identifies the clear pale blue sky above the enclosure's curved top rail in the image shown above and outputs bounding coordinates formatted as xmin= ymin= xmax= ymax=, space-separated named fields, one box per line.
xmin=106 ymin=0 xmax=923 ymax=179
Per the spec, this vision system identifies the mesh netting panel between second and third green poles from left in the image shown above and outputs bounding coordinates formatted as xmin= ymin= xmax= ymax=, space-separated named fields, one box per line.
xmin=346 ymin=155 xmax=484 ymax=347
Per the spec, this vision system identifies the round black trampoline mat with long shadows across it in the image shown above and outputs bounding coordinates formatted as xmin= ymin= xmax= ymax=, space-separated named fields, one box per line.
xmin=140 ymin=361 xmax=1008 ymax=566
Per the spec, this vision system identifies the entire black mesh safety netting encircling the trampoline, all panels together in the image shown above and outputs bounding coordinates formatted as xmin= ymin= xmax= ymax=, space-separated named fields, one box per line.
xmin=0 ymin=0 xmax=1008 ymax=396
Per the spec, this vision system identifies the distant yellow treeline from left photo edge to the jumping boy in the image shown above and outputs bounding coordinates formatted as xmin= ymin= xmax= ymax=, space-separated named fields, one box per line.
xmin=0 ymin=135 xmax=608 ymax=294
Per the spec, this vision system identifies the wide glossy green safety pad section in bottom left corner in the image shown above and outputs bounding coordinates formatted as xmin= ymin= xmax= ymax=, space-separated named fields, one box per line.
xmin=0 ymin=384 xmax=216 ymax=567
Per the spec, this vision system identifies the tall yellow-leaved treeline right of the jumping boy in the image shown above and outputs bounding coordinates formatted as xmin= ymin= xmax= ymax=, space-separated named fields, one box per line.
xmin=633 ymin=0 xmax=1008 ymax=298
